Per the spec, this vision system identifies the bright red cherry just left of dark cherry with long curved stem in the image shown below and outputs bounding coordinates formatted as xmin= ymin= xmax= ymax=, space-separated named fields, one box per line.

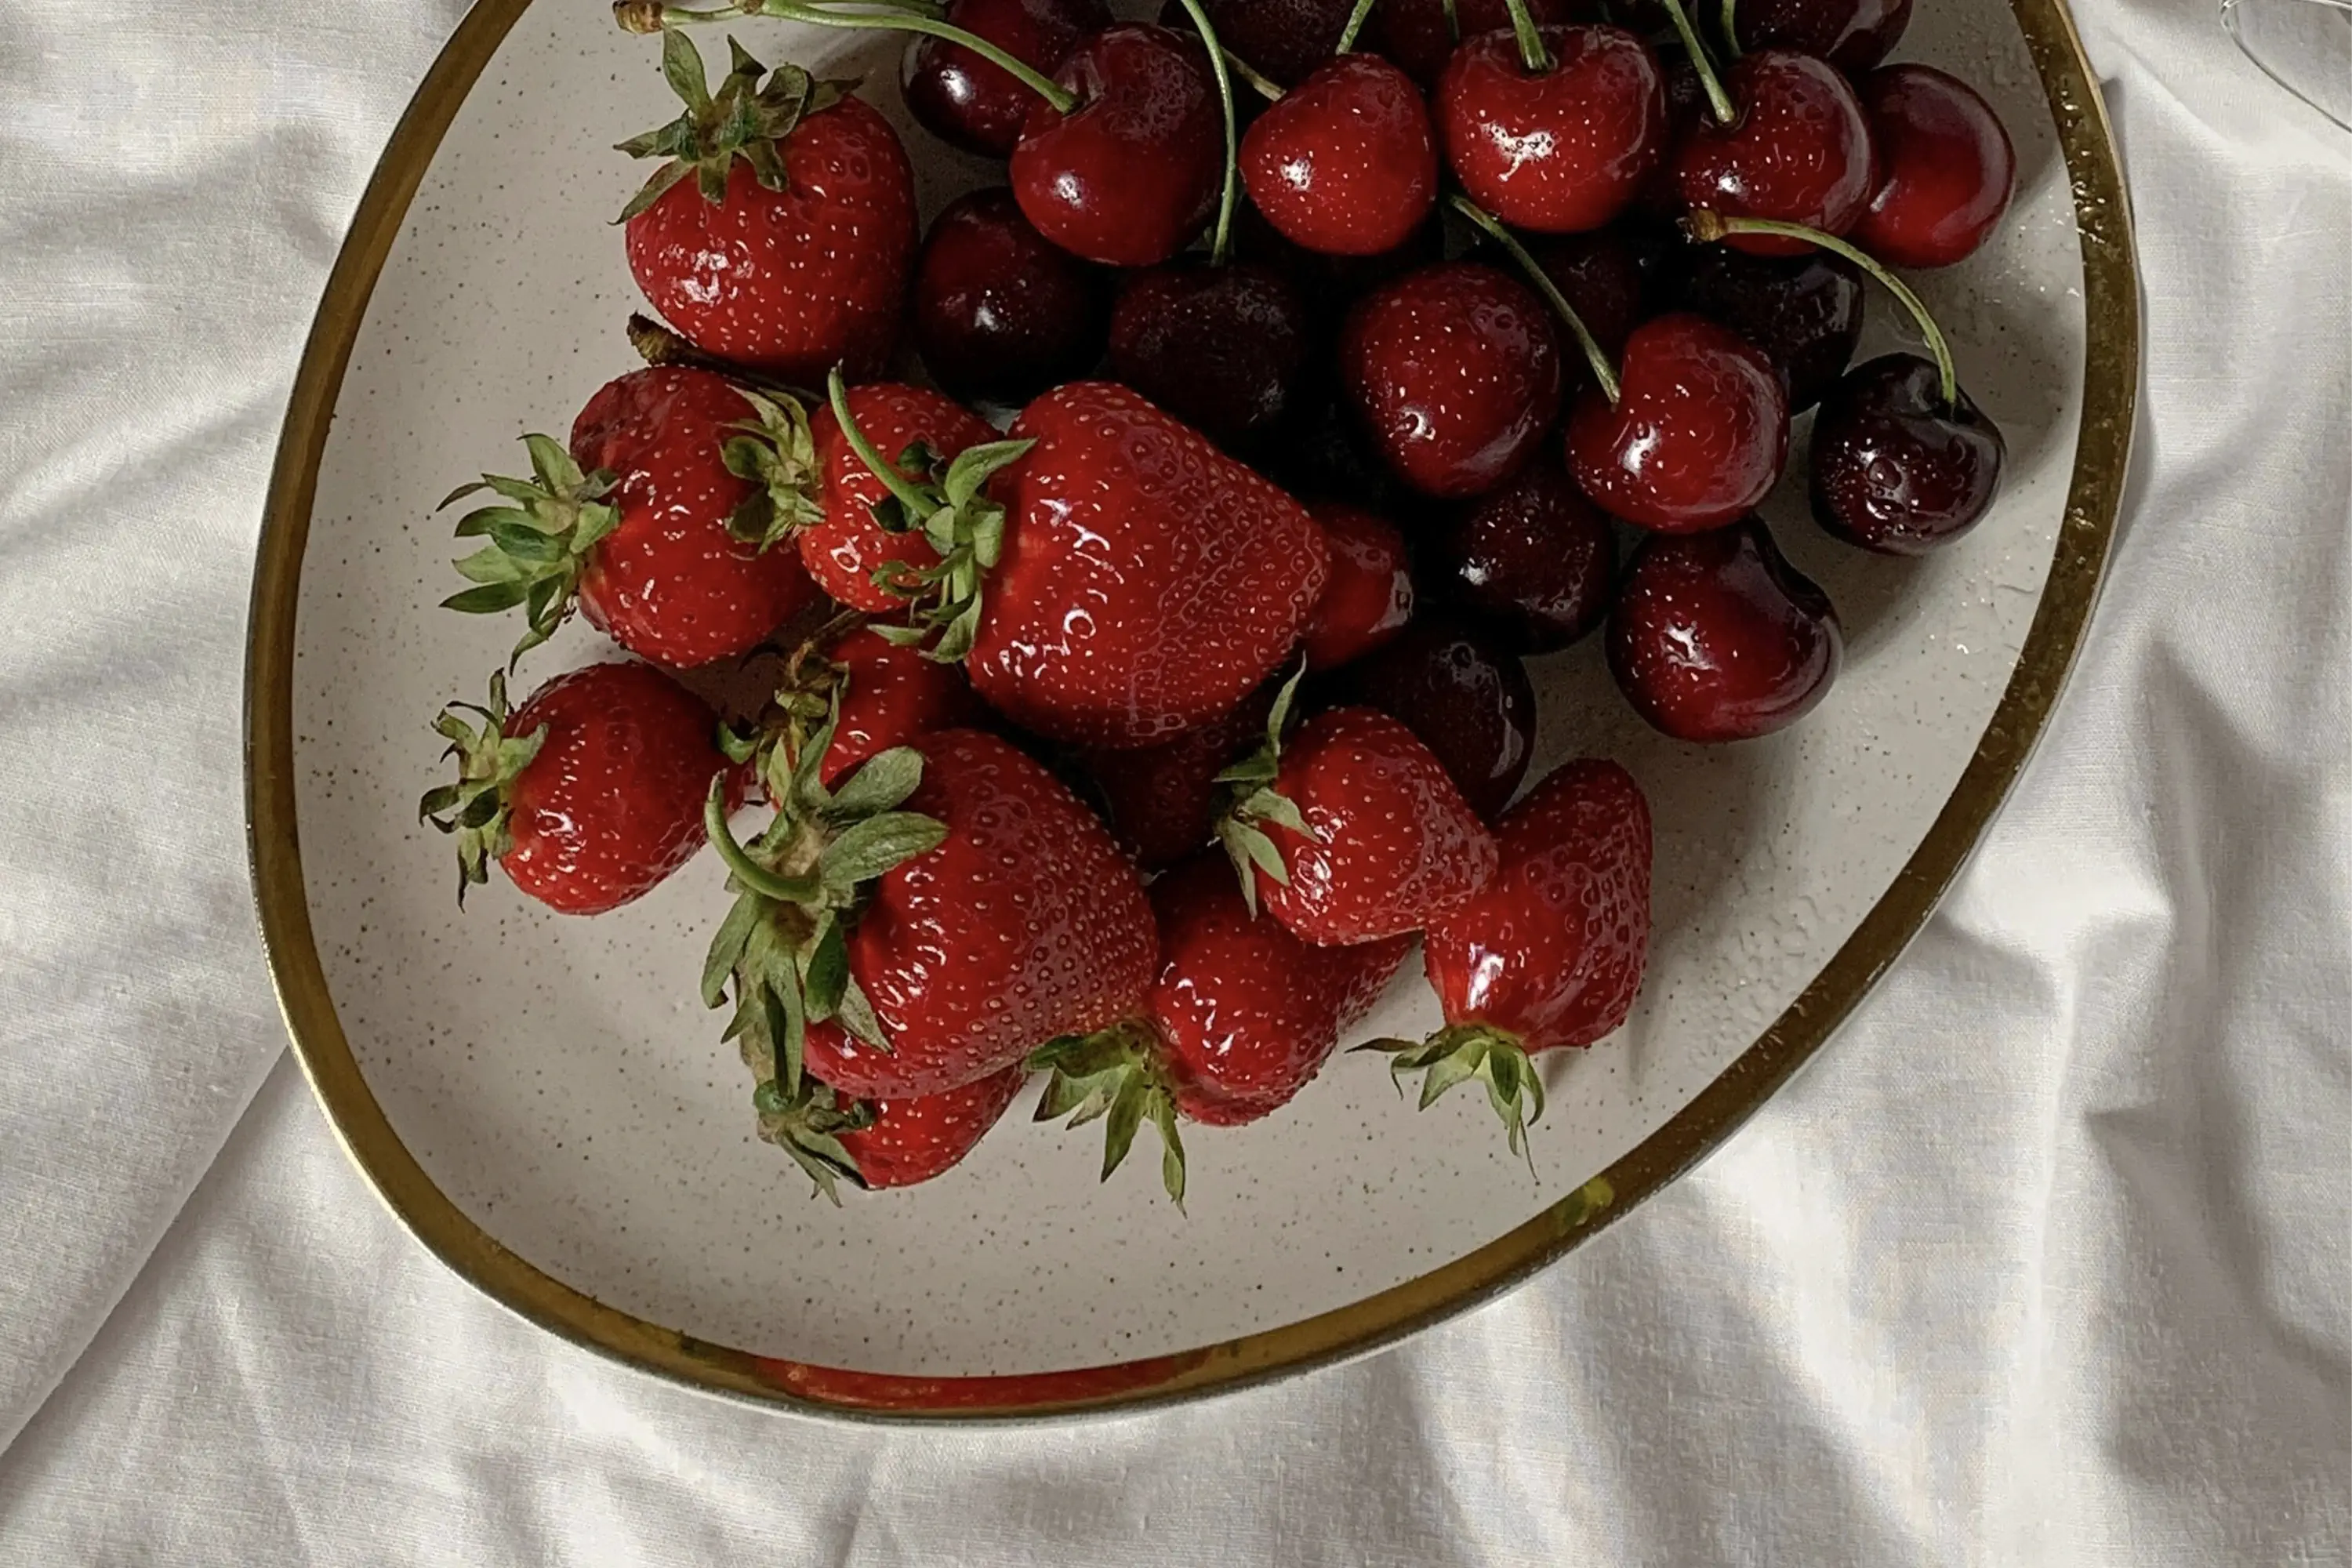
xmin=1566 ymin=313 xmax=1788 ymax=534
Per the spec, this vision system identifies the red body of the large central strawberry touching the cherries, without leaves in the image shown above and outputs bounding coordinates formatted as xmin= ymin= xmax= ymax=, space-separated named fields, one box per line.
xmin=934 ymin=381 xmax=1331 ymax=748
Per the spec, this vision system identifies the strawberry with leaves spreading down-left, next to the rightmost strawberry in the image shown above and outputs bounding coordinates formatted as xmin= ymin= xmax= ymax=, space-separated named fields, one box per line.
xmin=1030 ymin=855 xmax=1411 ymax=1203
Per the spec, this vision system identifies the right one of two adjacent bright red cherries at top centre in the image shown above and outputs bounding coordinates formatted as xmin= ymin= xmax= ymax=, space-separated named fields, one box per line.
xmin=1437 ymin=26 xmax=1665 ymax=233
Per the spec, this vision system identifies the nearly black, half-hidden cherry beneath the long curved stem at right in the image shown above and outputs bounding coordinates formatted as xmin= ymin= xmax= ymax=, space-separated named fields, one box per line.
xmin=1672 ymin=245 xmax=1863 ymax=414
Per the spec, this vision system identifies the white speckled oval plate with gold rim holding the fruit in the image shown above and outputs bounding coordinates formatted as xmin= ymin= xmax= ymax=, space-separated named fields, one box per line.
xmin=249 ymin=0 xmax=2138 ymax=1415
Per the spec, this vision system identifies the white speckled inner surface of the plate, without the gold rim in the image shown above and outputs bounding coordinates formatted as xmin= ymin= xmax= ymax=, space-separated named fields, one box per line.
xmin=292 ymin=0 xmax=2089 ymax=1401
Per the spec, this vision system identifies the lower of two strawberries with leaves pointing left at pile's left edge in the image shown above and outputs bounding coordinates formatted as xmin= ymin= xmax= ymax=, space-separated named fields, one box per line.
xmin=416 ymin=663 xmax=743 ymax=914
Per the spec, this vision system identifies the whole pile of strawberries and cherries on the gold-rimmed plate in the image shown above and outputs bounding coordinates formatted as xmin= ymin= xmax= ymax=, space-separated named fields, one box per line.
xmin=423 ymin=0 xmax=2013 ymax=1201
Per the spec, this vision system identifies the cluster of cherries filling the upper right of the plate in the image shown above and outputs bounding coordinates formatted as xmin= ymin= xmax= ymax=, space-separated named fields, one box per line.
xmin=619 ymin=0 xmax=2016 ymax=741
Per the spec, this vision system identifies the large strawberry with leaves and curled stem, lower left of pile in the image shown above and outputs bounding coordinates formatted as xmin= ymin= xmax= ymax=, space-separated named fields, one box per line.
xmin=703 ymin=727 xmax=1155 ymax=1102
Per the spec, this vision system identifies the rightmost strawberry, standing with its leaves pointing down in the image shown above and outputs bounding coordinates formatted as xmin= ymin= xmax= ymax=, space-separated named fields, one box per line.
xmin=1367 ymin=762 xmax=1649 ymax=1154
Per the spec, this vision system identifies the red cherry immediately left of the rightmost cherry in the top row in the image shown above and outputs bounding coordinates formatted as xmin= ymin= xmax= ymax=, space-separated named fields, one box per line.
xmin=1675 ymin=49 xmax=1877 ymax=256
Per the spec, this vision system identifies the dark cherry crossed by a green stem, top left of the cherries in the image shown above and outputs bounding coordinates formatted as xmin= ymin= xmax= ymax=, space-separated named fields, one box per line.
xmin=898 ymin=0 xmax=1110 ymax=158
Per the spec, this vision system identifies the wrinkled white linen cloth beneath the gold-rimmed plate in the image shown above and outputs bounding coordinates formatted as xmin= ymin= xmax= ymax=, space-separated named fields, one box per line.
xmin=0 ymin=0 xmax=2352 ymax=1568
